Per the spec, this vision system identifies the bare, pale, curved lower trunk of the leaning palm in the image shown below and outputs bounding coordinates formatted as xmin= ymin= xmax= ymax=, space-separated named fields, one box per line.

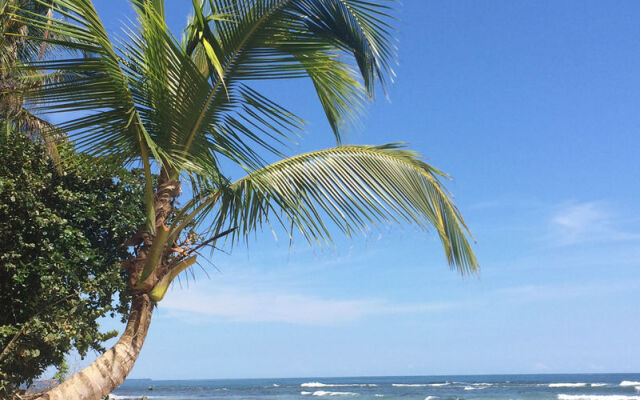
xmin=37 ymin=294 xmax=153 ymax=400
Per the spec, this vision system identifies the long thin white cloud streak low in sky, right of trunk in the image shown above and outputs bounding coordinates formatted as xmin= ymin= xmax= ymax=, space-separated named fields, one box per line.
xmin=160 ymin=287 xmax=456 ymax=325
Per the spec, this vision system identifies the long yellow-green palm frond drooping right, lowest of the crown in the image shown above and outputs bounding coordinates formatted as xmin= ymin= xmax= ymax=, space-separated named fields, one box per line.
xmin=198 ymin=144 xmax=478 ymax=273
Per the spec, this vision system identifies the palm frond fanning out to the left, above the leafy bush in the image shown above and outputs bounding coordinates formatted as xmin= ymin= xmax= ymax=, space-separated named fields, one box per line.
xmin=13 ymin=0 xmax=155 ymax=161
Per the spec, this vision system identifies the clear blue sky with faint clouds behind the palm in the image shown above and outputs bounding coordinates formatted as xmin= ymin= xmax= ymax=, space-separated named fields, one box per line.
xmin=63 ymin=0 xmax=640 ymax=379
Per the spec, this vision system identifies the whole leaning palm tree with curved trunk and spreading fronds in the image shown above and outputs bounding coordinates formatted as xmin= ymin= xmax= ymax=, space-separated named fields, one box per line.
xmin=14 ymin=0 xmax=477 ymax=400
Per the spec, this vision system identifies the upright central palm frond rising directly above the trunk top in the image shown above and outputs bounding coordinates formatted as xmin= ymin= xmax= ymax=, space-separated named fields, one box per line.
xmin=127 ymin=3 xmax=302 ymax=172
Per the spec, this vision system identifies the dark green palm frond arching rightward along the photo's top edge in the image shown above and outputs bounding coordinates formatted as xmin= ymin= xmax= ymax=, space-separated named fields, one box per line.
xmin=183 ymin=0 xmax=395 ymax=150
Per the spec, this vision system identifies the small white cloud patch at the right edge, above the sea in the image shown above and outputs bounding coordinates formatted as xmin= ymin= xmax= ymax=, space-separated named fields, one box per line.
xmin=550 ymin=202 xmax=640 ymax=245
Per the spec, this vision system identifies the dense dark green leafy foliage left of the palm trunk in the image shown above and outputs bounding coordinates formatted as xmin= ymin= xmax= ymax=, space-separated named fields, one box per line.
xmin=0 ymin=130 xmax=144 ymax=397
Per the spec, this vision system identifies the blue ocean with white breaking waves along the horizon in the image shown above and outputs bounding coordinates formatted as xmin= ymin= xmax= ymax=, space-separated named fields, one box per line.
xmin=111 ymin=374 xmax=640 ymax=400
